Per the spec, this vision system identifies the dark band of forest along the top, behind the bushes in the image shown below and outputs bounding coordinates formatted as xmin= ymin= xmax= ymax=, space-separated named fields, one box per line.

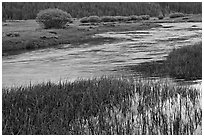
xmin=2 ymin=2 xmax=202 ymax=20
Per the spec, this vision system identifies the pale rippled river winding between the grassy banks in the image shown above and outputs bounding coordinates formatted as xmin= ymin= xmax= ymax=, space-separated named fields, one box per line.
xmin=2 ymin=23 xmax=202 ymax=87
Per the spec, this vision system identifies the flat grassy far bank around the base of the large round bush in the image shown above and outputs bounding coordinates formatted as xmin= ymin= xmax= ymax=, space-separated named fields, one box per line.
xmin=2 ymin=20 xmax=160 ymax=55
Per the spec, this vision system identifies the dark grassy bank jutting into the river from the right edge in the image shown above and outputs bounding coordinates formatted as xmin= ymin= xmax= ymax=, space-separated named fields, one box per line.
xmin=128 ymin=43 xmax=202 ymax=80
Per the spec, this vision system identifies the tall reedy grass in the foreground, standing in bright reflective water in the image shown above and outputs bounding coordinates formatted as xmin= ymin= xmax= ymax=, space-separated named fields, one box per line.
xmin=2 ymin=77 xmax=202 ymax=135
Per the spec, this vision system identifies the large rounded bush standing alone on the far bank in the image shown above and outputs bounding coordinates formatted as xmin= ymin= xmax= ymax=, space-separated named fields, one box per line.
xmin=36 ymin=9 xmax=71 ymax=29
